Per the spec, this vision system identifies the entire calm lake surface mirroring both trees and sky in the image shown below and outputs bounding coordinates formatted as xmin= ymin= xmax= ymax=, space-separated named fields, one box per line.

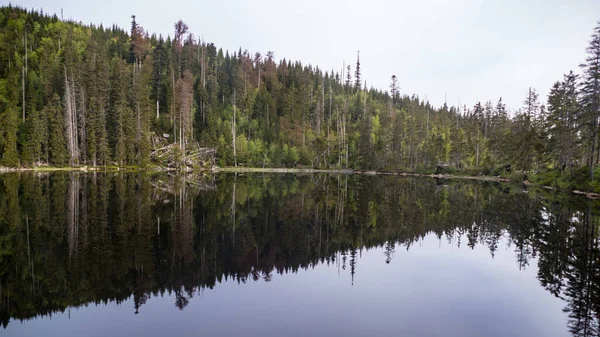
xmin=0 ymin=173 xmax=600 ymax=337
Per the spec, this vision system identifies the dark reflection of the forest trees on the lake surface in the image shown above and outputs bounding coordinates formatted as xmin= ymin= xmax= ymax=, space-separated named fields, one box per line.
xmin=0 ymin=173 xmax=600 ymax=336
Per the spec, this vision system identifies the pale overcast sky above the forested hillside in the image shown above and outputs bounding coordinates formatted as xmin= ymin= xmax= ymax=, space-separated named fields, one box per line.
xmin=9 ymin=0 xmax=600 ymax=109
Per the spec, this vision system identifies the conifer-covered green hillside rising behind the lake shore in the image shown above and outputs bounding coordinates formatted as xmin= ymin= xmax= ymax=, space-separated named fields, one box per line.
xmin=0 ymin=6 xmax=600 ymax=175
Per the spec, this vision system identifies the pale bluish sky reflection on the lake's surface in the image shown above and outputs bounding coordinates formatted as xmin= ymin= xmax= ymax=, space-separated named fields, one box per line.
xmin=2 ymin=234 xmax=569 ymax=337
